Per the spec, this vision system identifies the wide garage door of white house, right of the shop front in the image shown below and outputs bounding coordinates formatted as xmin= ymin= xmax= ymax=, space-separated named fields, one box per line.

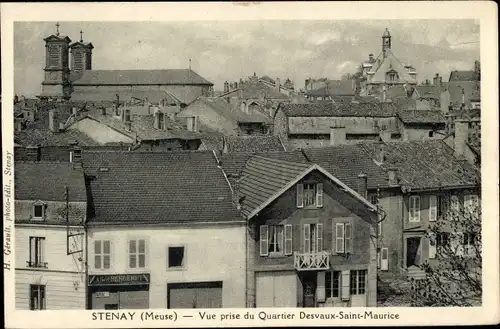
xmin=167 ymin=281 xmax=222 ymax=308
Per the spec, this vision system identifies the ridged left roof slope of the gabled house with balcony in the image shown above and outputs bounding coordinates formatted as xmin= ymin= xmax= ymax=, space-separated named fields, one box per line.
xmin=238 ymin=156 xmax=311 ymax=215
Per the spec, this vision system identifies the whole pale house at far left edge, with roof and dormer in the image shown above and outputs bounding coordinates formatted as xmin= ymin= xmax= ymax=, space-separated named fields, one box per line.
xmin=15 ymin=161 xmax=87 ymax=310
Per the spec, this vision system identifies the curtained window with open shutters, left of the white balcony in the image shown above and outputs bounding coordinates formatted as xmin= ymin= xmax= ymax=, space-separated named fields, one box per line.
xmin=259 ymin=224 xmax=292 ymax=256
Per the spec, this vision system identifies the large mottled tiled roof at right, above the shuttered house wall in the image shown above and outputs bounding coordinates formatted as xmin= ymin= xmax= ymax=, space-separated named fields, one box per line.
xmin=360 ymin=140 xmax=481 ymax=190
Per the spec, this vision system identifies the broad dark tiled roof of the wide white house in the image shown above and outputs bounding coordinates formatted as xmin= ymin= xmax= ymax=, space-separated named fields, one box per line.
xmin=83 ymin=151 xmax=242 ymax=223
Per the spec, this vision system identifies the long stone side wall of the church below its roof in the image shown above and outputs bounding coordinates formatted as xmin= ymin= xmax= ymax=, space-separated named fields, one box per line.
xmin=72 ymin=85 xmax=210 ymax=104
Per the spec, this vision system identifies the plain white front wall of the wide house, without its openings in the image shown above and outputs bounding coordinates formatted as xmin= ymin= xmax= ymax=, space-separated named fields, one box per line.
xmin=89 ymin=224 xmax=245 ymax=308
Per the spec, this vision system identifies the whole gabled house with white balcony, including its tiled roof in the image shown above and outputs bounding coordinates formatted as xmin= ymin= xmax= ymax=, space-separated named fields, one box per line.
xmin=237 ymin=156 xmax=377 ymax=307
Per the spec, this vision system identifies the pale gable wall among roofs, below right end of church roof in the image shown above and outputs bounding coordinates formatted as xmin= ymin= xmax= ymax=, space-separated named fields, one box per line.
xmin=177 ymin=100 xmax=238 ymax=136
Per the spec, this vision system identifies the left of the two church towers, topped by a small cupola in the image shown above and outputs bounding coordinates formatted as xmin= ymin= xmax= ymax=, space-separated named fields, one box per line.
xmin=41 ymin=23 xmax=71 ymax=99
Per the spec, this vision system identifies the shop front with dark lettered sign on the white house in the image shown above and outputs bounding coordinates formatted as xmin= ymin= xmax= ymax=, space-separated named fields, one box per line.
xmin=88 ymin=273 xmax=150 ymax=310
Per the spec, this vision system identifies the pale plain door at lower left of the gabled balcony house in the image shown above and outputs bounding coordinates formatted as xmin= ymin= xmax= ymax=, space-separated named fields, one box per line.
xmin=255 ymin=271 xmax=297 ymax=307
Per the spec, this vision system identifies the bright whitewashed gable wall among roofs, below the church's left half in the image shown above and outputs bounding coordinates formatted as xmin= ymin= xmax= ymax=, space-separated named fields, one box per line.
xmin=68 ymin=118 xmax=134 ymax=144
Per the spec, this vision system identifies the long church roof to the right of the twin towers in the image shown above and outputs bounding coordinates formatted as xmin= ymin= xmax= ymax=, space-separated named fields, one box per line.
xmin=73 ymin=69 xmax=213 ymax=86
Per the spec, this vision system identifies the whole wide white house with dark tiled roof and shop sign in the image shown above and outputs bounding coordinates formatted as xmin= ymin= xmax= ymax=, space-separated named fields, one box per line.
xmin=83 ymin=151 xmax=246 ymax=309
